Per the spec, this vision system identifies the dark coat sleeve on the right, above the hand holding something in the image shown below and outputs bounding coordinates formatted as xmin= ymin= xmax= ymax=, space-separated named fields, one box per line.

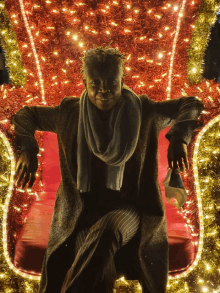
xmin=154 ymin=97 xmax=204 ymax=145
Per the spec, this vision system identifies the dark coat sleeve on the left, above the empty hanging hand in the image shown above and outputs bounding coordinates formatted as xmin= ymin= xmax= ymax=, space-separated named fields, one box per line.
xmin=11 ymin=106 xmax=60 ymax=153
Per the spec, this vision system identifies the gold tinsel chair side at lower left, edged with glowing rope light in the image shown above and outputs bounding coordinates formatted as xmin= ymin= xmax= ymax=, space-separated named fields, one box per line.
xmin=0 ymin=131 xmax=38 ymax=293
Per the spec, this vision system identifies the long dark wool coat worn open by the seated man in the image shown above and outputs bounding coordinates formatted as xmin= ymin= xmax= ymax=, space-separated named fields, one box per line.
xmin=13 ymin=95 xmax=203 ymax=293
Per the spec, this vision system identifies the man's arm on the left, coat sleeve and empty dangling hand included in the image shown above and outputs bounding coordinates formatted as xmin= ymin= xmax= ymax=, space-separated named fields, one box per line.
xmin=11 ymin=106 xmax=59 ymax=189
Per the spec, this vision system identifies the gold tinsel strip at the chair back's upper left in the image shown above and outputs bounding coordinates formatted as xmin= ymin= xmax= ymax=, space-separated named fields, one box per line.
xmin=0 ymin=1 xmax=27 ymax=86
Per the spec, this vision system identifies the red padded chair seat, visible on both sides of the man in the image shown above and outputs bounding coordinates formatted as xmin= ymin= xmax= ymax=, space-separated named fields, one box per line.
xmin=14 ymin=192 xmax=194 ymax=274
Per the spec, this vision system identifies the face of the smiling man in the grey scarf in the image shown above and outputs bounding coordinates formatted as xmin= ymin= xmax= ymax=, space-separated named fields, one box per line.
xmin=84 ymin=60 xmax=123 ymax=110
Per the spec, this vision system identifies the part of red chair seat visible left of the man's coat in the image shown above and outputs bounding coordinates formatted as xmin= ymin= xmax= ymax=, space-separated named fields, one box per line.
xmin=14 ymin=194 xmax=54 ymax=274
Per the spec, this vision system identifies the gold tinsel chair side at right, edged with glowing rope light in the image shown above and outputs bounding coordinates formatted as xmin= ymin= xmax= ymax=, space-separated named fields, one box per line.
xmin=168 ymin=116 xmax=220 ymax=293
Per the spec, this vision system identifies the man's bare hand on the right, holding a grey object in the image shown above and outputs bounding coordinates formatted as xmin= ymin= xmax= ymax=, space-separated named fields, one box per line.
xmin=167 ymin=139 xmax=189 ymax=172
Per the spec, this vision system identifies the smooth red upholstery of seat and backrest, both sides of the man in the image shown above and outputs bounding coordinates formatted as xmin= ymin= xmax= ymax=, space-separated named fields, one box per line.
xmin=14 ymin=129 xmax=195 ymax=274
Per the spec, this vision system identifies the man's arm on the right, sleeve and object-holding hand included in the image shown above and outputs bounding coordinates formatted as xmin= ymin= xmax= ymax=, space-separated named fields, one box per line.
xmin=155 ymin=97 xmax=204 ymax=171
